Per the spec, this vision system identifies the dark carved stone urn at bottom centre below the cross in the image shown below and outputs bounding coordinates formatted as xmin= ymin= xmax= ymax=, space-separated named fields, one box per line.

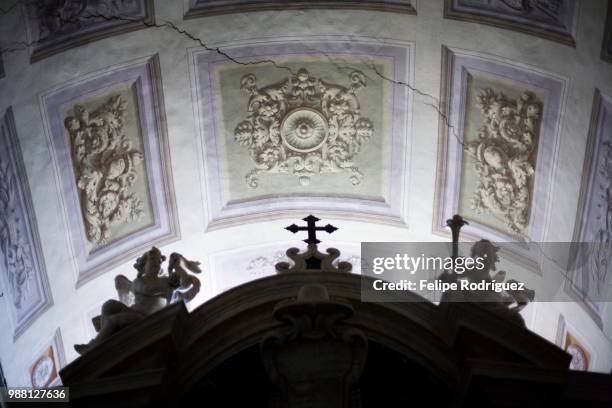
xmin=261 ymin=284 xmax=368 ymax=408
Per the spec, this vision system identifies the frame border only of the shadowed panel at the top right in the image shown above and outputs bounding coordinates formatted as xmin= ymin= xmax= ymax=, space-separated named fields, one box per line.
xmin=444 ymin=0 xmax=579 ymax=47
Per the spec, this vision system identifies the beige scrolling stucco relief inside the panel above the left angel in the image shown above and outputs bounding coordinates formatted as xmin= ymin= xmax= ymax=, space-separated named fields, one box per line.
xmin=64 ymin=95 xmax=143 ymax=246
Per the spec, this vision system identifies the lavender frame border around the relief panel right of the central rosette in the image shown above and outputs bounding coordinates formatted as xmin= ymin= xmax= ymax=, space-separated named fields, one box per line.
xmin=432 ymin=46 xmax=568 ymax=274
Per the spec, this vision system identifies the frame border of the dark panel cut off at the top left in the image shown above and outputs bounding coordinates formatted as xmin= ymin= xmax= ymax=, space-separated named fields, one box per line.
xmin=22 ymin=0 xmax=155 ymax=63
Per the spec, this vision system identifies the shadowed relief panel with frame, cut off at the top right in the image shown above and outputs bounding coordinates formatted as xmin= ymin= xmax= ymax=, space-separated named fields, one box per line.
xmin=444 ymin=0 xmax=579 ymax=46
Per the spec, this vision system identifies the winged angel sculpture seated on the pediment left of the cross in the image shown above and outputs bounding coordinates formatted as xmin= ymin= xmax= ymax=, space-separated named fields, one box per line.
xmin=74 ymin=247 xmax=201 ymax=354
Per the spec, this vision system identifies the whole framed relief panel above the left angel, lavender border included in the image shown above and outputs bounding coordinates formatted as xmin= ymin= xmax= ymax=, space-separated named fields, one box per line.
xmin=41 ymin=57 xmax=178 ymax=283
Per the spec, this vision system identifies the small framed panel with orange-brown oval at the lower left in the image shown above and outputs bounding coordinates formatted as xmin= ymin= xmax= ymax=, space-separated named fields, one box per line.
xmin=28 ymin=329 xmax=66 ymax=388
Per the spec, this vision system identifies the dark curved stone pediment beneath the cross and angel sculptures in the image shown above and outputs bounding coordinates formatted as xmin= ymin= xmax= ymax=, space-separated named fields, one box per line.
xmin=60 ymin=272 xmax=611 ymax=407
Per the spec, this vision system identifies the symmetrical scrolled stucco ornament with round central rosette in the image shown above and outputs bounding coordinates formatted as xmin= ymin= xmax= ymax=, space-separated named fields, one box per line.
xmin=234 ymin=68 xmax=374 ymax=188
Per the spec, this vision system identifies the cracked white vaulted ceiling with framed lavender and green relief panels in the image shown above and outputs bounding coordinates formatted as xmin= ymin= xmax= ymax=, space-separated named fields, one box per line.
xmin=0 ymin=0 xmax=612 ymax=384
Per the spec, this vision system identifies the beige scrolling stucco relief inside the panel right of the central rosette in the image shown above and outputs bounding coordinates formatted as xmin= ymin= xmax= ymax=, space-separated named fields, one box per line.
xmin=465 ymin=88 xmax=542 ymax=235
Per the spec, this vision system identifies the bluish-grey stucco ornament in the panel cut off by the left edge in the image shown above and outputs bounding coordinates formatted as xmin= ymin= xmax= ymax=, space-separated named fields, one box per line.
xmin=0 ymin=163 xmax=34 ymax=309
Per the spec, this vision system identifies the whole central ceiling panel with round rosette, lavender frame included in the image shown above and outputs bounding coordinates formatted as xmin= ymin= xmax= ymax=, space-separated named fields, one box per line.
xmin=193 ymin=40 xmax=411 ymax=227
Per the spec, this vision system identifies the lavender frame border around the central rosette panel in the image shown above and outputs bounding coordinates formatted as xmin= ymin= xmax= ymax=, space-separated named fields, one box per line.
xmin=191 ymin=37 xmax=414 ymax=230
